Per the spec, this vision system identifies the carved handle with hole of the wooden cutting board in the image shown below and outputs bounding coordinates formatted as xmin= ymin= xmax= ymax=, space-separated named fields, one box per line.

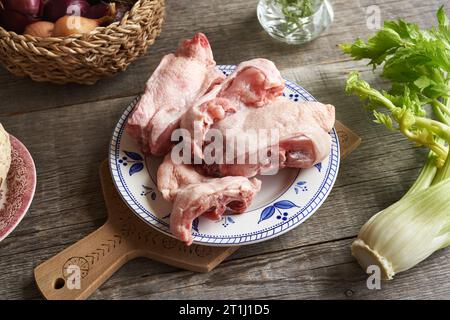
xmin=34 ymin=221 xmax=139 ymax=300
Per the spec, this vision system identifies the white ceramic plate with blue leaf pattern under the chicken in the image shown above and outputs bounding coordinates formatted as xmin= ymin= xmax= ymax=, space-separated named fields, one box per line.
xmin=109 ymin=65 xmax=339 ymax=246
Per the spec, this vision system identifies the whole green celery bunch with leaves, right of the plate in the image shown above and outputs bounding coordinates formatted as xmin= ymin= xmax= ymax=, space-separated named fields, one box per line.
xmin=341 ymin=6 xmax=450 ymax=279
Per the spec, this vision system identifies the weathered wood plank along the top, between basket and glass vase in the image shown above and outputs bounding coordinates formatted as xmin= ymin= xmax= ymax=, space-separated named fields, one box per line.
xmin=0 ymin=0 xmax=442 ymax=117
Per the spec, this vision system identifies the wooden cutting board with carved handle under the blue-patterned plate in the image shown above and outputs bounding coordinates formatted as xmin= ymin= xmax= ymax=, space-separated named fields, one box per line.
xmin=34 ymin=122 xmax=361 ymax=300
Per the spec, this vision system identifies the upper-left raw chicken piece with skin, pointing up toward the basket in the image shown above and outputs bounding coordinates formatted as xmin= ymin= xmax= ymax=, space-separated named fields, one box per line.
xmin=126 ymin=33 xmax=224 ymax=155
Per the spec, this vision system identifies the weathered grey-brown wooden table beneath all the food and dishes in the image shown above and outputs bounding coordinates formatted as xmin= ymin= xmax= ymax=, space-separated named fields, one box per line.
xmin=0 ymin=0 xmax=450 ymax=299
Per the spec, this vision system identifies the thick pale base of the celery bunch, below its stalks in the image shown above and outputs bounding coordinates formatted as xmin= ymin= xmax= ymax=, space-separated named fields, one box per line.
xmin=352 ymin=179 xmax=450 ymax=280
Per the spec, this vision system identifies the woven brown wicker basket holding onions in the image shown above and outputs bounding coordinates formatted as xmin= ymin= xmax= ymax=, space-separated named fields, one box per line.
xmin=0 ymin=0 xmax=164 ymax=84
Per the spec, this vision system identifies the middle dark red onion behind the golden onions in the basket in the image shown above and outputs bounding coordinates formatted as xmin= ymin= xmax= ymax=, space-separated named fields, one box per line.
xmin=44 ymin=0 xmax=89 ymax=22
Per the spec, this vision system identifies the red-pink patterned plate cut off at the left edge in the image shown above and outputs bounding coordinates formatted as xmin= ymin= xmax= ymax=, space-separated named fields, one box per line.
xmin=0 ymin=135 xmax=36 ymax=241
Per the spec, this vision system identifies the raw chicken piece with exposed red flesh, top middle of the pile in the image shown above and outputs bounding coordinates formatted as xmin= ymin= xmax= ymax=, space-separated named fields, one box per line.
xmin=180 ymin=59 xmax=284 ymax=159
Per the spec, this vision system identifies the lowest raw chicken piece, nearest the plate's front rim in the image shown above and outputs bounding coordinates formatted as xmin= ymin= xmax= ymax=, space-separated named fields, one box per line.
xmin=157 ymin=155 xmax=261 ymax=245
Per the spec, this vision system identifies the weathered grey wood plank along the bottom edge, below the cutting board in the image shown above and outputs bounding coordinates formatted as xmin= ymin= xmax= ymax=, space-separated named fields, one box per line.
xmin=88 ymin=239 xmax=450 ymax=300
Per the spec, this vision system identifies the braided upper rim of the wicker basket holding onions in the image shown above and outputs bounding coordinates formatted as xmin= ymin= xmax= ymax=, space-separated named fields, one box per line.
xmin=0 ymin=0 xmax=165 ymax=46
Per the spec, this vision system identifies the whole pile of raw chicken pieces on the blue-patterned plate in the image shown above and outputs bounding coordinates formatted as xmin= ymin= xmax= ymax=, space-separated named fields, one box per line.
xmin=126 ymin=33 xmax=334 ymax=245
